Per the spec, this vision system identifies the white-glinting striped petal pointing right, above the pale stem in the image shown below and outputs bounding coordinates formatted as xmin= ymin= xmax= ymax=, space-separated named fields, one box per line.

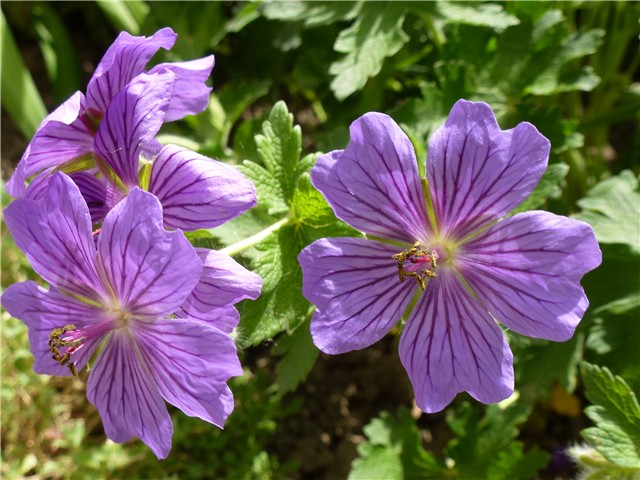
xmin=149 ymin=145 xmax=256 ymax=230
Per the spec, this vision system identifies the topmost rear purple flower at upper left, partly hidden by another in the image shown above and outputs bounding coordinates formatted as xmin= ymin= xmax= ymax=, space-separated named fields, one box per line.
xmin=7 ymin=28 xmax=214 ymax=197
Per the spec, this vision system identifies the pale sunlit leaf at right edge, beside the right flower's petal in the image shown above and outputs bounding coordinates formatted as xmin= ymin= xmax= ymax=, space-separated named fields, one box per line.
xmin=574 ymin=170 xmax=640 ymax=255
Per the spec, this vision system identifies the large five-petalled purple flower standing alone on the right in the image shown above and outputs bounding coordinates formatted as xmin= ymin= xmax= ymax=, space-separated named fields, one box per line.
xmin=298 ymin=100 xmax=601 ymax=412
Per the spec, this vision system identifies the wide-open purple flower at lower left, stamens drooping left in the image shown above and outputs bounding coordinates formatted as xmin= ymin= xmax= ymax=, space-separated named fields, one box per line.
xmin=2 ymin=173 xmax=261 ymax=458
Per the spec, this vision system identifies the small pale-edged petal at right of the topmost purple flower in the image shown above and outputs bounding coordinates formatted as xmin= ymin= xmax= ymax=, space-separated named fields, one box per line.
xmin=149 ymin=55 xmax=214 ymax=122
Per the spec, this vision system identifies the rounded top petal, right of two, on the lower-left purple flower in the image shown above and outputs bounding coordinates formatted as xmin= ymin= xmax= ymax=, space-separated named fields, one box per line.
xmin=97 ymin=188 xmax=202 ymax=316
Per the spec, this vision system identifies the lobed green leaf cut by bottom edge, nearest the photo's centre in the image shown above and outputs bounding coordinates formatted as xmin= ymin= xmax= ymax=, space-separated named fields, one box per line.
xmin=349 ymin=408 xmax=447 ymax=480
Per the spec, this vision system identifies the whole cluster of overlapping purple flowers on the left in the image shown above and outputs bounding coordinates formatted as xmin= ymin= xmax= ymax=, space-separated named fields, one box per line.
xmin=2 ymin=28 xmax=261 ymax=458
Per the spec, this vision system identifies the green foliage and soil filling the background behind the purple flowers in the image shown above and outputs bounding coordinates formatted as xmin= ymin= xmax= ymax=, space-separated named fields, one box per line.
xmin=0 ymin=0 xmax=640 ymax=480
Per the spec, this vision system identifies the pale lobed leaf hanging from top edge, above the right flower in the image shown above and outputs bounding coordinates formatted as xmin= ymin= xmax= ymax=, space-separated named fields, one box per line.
xmin=329 ymin=2 xmax=409 ymax=100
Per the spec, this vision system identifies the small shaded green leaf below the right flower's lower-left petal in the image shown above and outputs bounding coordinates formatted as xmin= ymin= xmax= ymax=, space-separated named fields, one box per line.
xmin=273 ymin=319 xmax=320 ymax=395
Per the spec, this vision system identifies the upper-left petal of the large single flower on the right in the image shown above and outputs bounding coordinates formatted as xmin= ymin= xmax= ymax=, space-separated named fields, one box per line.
xmin=311 ymin=113 xmax=429 ymax=243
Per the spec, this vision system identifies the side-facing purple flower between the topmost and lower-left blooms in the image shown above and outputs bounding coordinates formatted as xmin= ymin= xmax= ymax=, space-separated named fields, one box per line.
xmin=16 ymin=70 xmax=256 ymax=230
